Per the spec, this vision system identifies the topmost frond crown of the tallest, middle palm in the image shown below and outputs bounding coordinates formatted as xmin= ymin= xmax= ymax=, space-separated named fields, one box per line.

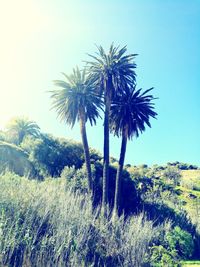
xmin=87 ymin=44 xmax=137 ymax=97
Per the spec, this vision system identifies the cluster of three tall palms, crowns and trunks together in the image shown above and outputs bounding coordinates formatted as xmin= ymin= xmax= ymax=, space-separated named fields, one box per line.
xmin=51 ymin=44 xmax=157 ymax=216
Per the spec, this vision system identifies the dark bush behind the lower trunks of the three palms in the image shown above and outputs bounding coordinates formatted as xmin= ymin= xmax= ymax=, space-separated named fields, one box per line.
xmin=61 ymin=162 xmax=141 ymax=215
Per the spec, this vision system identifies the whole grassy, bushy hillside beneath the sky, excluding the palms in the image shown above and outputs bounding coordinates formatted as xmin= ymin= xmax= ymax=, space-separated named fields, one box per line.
xmin=0 ymin=135 xmax=200 ymax=267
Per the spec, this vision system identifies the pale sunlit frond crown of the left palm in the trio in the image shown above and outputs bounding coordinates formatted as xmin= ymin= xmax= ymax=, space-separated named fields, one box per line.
xmin=50 ymin=67 xmax=103 ymax=127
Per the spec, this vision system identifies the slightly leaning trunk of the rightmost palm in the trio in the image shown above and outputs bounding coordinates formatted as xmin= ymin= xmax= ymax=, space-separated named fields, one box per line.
xmin=113 ymin=131 xmax=127 ymax=216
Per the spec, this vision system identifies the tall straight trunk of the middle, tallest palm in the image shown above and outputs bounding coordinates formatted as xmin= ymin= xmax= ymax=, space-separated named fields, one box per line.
xmin=102 ymin=90 xmax=111 ymax=217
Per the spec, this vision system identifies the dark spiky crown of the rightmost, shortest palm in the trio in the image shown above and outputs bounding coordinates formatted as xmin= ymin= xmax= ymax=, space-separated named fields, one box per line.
xmin=111 ymin=86 xmax=157 ymax=139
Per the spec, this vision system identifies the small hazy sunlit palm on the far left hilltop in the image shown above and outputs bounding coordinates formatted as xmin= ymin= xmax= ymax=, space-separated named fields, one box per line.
xmin=6 ymin=117 xmax=40 ymax=145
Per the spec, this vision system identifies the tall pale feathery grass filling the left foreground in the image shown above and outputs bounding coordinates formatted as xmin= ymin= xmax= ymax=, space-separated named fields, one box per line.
xmin=0 ymin=173 xmax=167 ymax=267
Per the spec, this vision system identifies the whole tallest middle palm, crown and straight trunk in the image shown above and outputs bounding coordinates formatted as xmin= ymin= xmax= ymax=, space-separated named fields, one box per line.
xmin=87 ymin=44 xmax=136 ymax=216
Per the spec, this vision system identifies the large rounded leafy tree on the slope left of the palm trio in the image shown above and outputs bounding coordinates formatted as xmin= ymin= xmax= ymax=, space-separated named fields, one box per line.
xmin=21 ymin=134 xmax=84 ymax=177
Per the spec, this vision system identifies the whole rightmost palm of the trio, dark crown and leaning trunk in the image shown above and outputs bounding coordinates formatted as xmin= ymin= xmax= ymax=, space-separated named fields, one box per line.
xmin=110 ymin=86 xmax=157 ymax=215
